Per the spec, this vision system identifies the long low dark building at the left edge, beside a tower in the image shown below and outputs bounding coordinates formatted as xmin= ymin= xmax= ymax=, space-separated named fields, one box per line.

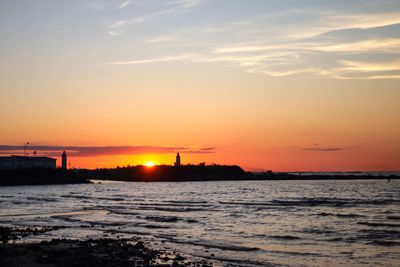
xmin=0 ymin=156 xmax=57 ymax=170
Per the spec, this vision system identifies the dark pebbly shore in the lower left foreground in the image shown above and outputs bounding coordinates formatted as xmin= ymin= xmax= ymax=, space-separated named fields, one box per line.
xmin=0 ymin=227 xmax=212 ymax=267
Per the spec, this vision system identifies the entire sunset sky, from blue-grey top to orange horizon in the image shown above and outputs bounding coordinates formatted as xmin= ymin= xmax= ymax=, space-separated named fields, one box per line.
xmin=0 ymin=0 xmax=400 ymax=171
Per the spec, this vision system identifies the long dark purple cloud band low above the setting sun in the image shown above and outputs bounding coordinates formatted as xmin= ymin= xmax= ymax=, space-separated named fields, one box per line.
xmin=0 ymin=145 xmax=215 ymax=157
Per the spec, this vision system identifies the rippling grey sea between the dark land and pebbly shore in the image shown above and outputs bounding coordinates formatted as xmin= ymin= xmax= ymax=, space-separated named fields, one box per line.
xmin=0 ymin=180 xmax=400 ymax=266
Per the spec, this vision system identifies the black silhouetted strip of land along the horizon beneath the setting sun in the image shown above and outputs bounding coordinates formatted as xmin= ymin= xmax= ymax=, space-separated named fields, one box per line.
xmin=0 ymin=164 xmax=400 ymax=186
